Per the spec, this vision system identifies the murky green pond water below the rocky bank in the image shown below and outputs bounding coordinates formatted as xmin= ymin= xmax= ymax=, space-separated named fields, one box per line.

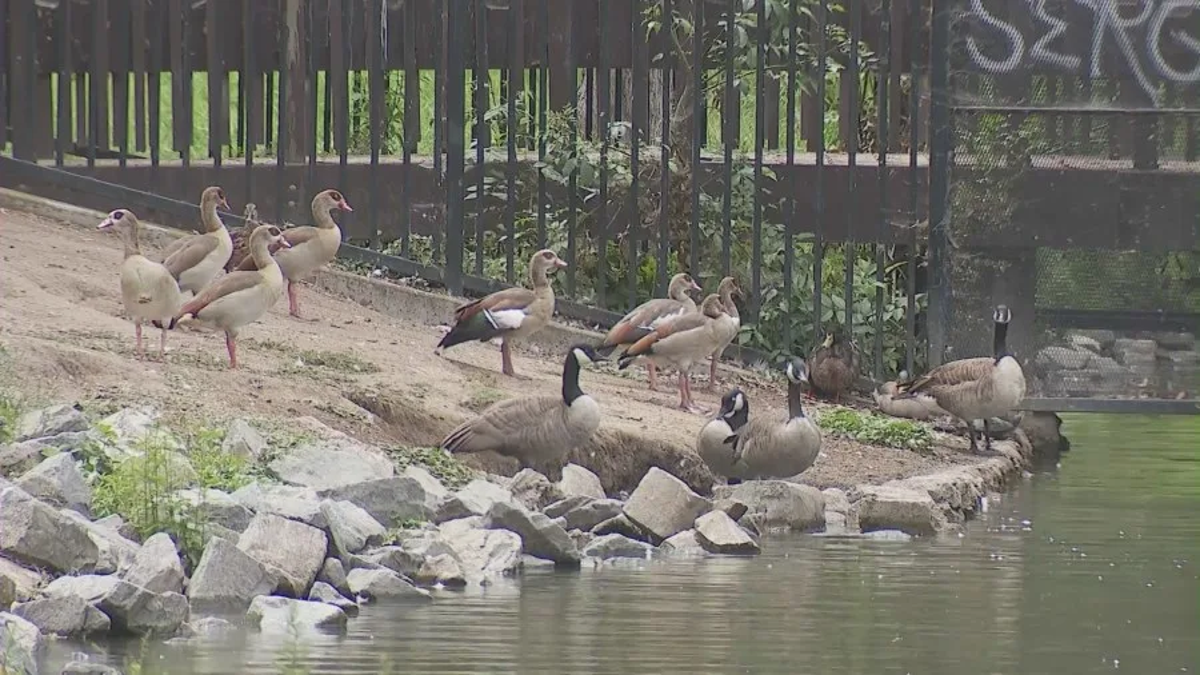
xmin=50 ymin=416 xmax=1200 ymax=675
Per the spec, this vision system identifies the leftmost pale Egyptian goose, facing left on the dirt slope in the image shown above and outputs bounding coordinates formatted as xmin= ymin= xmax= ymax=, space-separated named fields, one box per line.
xmin=97 ymin=209 xmax=184 ymax=360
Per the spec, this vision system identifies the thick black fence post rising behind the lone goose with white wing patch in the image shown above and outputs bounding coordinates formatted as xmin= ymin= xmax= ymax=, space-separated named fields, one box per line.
xmin=445 ymin=0 xmax=470 ymax=294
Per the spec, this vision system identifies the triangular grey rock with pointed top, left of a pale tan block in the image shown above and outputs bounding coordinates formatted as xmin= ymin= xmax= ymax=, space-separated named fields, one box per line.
xmin=187 ymin=538 xmax=277 ymax=611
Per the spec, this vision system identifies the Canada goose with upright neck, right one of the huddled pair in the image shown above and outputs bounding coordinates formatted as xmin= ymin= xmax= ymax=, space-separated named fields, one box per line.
xmin=733 ymin=358 xmax=821 ymax=479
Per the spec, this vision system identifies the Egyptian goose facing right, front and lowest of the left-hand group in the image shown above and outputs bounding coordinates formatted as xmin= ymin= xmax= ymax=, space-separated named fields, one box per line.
xmin=172 ymin=225 xmax=290 ymax=368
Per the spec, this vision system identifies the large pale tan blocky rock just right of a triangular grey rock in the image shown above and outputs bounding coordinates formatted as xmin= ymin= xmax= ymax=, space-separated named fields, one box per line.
xmin=238 ymin=513 xmax=329 ymax=590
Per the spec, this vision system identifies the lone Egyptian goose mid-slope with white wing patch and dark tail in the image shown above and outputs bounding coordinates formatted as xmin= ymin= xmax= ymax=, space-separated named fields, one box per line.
xmin=433 ymin=249 xmax=566 ymax=376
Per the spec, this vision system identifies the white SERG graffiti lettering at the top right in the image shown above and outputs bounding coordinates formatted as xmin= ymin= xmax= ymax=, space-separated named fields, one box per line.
xmin=966 ymin=0 xmax=1200 ymax=104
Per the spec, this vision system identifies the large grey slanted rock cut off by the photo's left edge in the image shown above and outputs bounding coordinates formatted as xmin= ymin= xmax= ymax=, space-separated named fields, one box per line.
xmin=0 ymin=488 xmax=100 ymax=573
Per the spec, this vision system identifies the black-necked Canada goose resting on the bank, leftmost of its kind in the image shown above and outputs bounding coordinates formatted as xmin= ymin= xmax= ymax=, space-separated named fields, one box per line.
xmin=442 ymin=345 xmax=600 ymax=480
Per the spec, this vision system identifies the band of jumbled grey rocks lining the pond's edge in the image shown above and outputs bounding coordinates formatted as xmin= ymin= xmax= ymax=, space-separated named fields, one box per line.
xmin=0 ymin=396 xmax=1032 ymax=674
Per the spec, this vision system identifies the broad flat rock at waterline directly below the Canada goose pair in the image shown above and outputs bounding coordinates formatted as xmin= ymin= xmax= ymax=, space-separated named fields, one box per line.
xmin=714 ymin=480 xmax=824 ymax=532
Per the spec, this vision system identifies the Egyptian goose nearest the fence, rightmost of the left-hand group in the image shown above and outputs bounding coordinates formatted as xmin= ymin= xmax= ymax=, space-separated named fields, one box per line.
xmin=236 ymin=190 xmax=354 ymax=318
